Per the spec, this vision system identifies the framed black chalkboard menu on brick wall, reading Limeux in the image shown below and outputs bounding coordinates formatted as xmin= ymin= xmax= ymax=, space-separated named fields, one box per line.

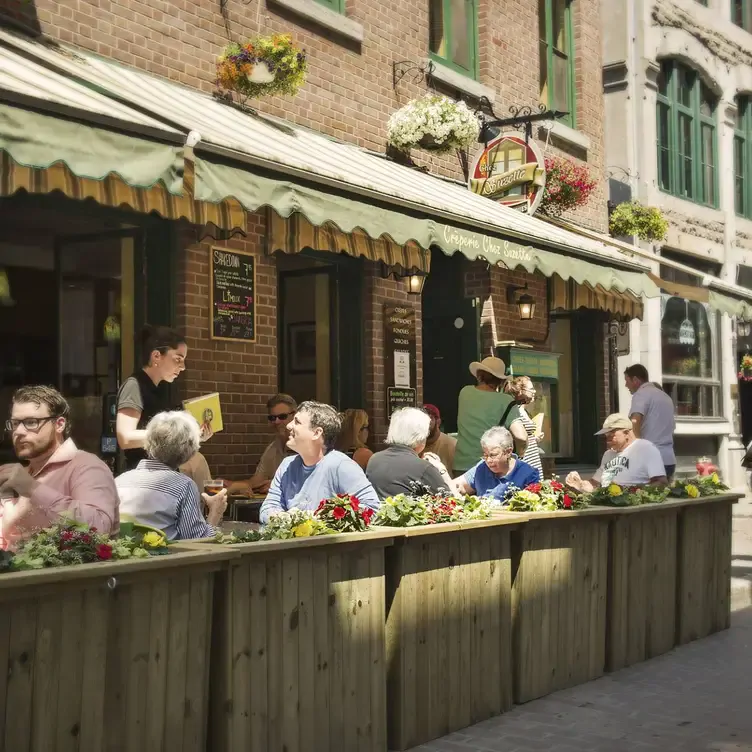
xmin=209 ymin=247 xmax=256 ymax=342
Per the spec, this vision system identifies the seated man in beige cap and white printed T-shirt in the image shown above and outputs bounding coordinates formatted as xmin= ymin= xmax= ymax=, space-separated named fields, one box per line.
xmin=566 ymin=413 xmax=668 ymax=493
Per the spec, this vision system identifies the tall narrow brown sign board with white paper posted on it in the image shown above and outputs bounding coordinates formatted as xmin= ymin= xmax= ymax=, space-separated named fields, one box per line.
xmin=384 ymin=303 xmax=417 ymax=408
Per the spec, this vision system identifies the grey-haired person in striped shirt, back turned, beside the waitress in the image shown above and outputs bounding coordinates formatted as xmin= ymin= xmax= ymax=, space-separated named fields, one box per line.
xmin=115 ymin=412 xmax=227 ymax=540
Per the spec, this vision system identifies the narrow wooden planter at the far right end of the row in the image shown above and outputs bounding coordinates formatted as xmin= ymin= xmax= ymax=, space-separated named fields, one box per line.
xmin=676 ymin=494 xmax=741 ymax=645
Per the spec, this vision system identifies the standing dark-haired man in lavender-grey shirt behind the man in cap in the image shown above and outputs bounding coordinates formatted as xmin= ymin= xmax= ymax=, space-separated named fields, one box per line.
xmin=624 ymin=363 xmax=676 ymax=478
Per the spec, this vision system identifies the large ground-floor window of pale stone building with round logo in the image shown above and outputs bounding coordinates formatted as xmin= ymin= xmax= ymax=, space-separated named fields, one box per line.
xmin=661 ymin=295 xmax=720 ymax=418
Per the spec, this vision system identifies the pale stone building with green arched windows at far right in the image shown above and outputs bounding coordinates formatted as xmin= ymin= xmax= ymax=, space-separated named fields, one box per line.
xmin=601 ymin=0 xmax=752 ymax=485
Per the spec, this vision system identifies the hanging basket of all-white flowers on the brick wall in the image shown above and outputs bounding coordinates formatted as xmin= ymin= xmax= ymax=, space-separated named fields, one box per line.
xmin=387 ymin=94 xmax=480 ymax=153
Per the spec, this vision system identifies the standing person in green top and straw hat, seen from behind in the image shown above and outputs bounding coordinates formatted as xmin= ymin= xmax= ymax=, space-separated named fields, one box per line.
xmin=454 ymin=358 xmax=527 ymax=475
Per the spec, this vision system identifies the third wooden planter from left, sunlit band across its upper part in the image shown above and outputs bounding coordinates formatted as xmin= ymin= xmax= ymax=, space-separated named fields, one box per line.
xmin=385 ymin=515 xmax=521 ymax=750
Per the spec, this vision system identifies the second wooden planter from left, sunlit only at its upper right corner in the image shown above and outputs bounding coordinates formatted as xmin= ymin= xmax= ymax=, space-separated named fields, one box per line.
xmin=176 ymin=531 xmax=393 ymax=752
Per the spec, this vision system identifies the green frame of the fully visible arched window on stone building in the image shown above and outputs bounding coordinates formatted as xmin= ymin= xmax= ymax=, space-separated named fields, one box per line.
xmin=656 ymin=60 xmax=719 ymax=209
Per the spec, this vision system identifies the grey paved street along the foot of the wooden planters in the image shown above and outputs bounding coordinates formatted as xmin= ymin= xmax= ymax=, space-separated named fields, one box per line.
xmin=413 ymin=503 xmax=752 ymax=752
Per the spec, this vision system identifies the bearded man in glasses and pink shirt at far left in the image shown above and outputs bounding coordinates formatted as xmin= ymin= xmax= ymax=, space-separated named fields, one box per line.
xmin=0 ymin=386 xmax=120 ymax=548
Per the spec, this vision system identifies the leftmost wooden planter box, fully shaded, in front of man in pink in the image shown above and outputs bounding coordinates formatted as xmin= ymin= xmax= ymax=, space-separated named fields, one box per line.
xmin=0 ymin=551 xmax=233 ymax=752
